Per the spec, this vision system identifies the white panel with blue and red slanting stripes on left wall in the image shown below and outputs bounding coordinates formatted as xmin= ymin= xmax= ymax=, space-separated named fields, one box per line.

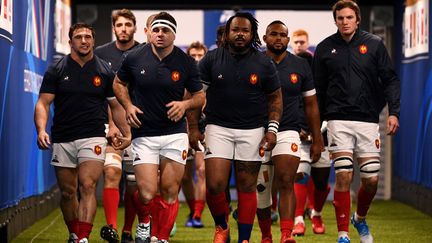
xmin=24 ymin=0 xmax=51 ymax=61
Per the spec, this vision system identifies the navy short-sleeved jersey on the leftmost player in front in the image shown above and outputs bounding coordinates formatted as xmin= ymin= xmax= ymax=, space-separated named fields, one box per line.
xmin=39 ymin=55 xmax=114 ymax=143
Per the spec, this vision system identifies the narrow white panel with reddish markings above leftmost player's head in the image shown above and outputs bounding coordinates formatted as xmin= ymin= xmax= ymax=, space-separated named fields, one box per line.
xmin=54 ymin=0 xmax=72 ymax=54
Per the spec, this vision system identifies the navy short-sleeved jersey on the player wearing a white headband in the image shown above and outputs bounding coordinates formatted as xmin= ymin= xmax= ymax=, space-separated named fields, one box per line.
xmin=117 ymin=44 xmax=202 ymax=138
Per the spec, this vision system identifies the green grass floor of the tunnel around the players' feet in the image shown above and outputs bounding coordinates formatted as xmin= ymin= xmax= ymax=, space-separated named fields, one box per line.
xmin=12 ymin=201 xmax=432 ymax=243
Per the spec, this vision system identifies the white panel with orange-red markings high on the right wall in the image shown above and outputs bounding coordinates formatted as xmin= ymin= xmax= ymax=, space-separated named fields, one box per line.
xmin=403 ymin=0 xmax=429 ymax=59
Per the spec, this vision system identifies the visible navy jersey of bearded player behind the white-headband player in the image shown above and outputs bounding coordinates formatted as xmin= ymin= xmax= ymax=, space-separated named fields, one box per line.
xmin=94 ymin=41 xmax=139 ymax=72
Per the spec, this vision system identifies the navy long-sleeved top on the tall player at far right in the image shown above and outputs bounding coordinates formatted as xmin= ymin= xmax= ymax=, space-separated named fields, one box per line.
xmin=312 ymin=29 xmax=400 ymax=123
